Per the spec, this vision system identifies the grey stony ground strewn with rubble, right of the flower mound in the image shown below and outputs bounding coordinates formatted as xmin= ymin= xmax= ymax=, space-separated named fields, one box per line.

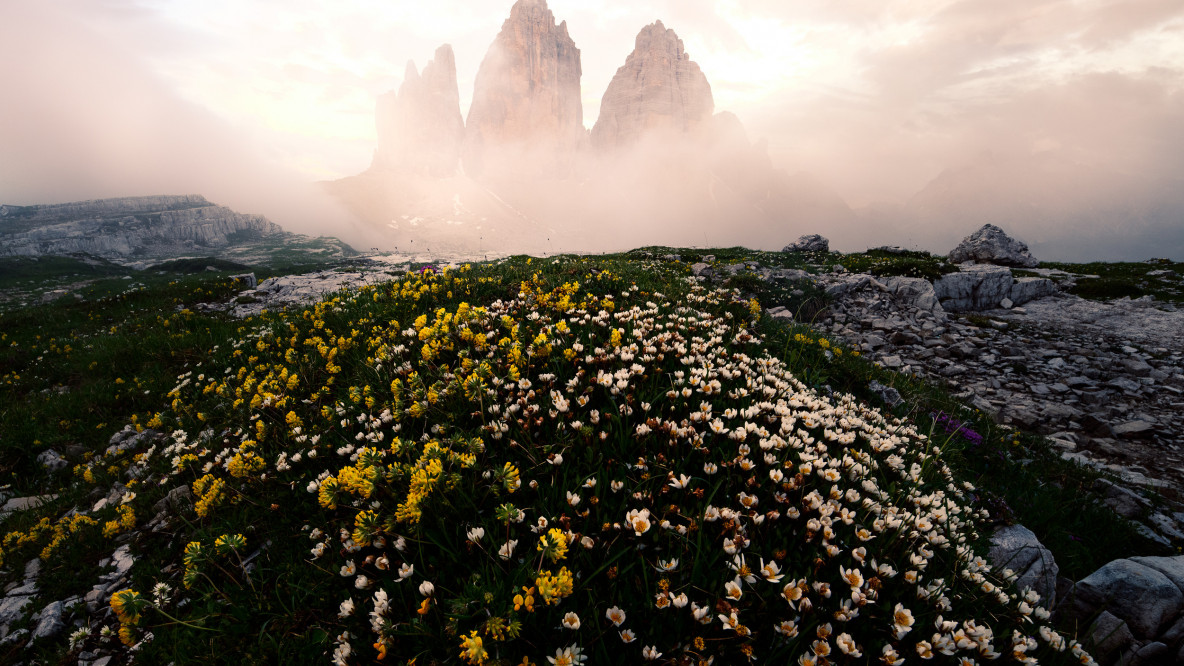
xmin=800 ymin=259 xmax=1184 ymax=492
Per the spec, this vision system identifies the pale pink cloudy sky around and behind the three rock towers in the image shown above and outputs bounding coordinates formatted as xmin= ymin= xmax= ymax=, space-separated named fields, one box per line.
xmin=0 ymin=0 xmax=1184 ymax=220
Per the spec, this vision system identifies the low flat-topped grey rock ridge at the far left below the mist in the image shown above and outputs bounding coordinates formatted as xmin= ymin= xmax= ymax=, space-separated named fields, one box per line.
xmin=0 ymin=194 xmax=353 ymax=264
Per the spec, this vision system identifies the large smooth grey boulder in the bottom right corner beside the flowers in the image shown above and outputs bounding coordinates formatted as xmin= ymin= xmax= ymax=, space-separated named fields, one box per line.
xmin=1062 ymin=558 xmax=1184 ymax=639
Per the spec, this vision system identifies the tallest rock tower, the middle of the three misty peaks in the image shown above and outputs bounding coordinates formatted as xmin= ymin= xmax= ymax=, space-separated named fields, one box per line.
xmin=462 ymin=0 xmax=586 ymax=177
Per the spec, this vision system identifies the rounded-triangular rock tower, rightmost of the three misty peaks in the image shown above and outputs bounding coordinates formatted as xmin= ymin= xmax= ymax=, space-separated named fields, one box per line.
xmin=592 ymin=21 xmax=715 ymax=148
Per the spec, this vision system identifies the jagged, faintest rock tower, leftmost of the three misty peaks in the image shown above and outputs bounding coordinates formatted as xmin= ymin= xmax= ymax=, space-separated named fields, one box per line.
xmin=374 ymin=44 xmax=464 ymax=178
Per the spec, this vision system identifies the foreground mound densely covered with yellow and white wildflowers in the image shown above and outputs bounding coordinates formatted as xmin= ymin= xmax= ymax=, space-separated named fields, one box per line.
xmin=78 ymin=261 xmax=1088 ymax=665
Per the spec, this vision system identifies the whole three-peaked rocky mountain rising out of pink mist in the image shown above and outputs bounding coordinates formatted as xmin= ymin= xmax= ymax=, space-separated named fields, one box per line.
xmin=324 ymin=0 xmax=856 ymax=255
